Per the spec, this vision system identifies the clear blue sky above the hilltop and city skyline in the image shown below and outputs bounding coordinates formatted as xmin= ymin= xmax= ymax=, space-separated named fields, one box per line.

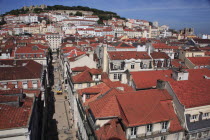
xmin=0 ymin=0 xmax=210 ymax=34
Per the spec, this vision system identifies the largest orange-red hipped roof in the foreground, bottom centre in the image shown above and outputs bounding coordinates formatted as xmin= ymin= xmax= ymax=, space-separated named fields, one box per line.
xmin=89 ymin=89 xmax=183 ymax=132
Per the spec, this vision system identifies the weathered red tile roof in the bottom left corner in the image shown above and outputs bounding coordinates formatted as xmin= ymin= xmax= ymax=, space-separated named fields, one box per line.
xmin=0 ymin=97 xmax=33 ymax=130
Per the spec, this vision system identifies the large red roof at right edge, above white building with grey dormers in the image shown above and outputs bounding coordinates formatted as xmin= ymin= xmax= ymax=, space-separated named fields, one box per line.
xmin=169 ymin=79 xmax=210 ymax=108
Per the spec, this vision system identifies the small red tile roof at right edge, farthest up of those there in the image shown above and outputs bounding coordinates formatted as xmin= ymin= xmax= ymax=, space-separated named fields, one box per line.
xmin=187 ymin=57 xmax=210 ymax=66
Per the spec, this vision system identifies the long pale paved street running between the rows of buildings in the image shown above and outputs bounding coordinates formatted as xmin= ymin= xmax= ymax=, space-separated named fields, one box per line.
xmin=48 ymin=57 xmax=76 ymax=140
